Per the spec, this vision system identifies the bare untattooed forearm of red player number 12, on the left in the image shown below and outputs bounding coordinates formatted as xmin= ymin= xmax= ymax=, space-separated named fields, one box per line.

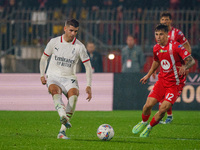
xmin=140 ymin=60 xmax=160 ymax=84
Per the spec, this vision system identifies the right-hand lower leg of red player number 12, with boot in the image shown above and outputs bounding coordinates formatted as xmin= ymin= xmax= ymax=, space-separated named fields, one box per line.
xmin=140 ymin=101 xmax=172 ymax=137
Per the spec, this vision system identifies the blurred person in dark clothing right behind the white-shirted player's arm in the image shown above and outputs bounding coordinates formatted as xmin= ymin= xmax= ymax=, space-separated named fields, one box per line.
xmin=82 ymin=42 xmax=103 ymax=72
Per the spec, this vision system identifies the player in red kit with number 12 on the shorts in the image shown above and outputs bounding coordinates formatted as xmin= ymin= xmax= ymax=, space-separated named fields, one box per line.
xmin=132 ymin=24 xmax=195 ymax=137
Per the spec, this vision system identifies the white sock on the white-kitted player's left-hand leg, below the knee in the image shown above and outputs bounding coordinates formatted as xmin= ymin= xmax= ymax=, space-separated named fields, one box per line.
xmin=53 ymin=94 xmax=66 ymax=117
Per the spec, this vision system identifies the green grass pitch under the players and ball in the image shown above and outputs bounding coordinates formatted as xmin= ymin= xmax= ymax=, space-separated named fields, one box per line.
xmin=0 ymin=111 xmax=200 ymax=150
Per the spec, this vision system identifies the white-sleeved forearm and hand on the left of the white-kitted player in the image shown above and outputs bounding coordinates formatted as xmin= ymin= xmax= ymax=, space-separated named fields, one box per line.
xmin=40 ymin=54 xmax=49 ymax=85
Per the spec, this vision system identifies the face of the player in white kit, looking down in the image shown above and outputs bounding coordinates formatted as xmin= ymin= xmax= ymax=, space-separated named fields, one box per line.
xmin=64 ymin=25 xmax=79 ymax=42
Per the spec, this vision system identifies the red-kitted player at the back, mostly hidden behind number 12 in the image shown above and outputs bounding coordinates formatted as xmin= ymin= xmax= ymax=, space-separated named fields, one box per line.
xmin=159 ymin=12 xmax=192 ymax=124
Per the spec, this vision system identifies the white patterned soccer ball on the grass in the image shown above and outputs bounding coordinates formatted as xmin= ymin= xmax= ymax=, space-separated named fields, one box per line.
xmin=97 ymin=124 xmax=114 ymax=141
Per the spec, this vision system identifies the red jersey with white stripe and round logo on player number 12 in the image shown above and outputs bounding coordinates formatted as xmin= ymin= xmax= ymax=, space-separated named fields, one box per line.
xmin=153 ymin=40 xmax=191 ymax=87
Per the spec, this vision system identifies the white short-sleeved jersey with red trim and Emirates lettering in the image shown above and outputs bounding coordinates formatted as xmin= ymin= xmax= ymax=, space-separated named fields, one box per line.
xmin=44 ymin=35 xmax=90 ymax=78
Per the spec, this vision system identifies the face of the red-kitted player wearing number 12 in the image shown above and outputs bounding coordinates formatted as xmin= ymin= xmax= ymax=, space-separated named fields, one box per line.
xmin=155 ymin=30 xmax=168 ymax=46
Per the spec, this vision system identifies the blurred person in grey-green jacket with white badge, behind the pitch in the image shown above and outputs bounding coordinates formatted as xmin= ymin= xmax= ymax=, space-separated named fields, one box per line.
xmin=122 ymin=35 xmax=145 ymax=72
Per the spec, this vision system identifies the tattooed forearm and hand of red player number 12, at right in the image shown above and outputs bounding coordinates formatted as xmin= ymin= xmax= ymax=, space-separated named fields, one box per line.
xmin=179 ymin=55 xmax=195 ymax=75
